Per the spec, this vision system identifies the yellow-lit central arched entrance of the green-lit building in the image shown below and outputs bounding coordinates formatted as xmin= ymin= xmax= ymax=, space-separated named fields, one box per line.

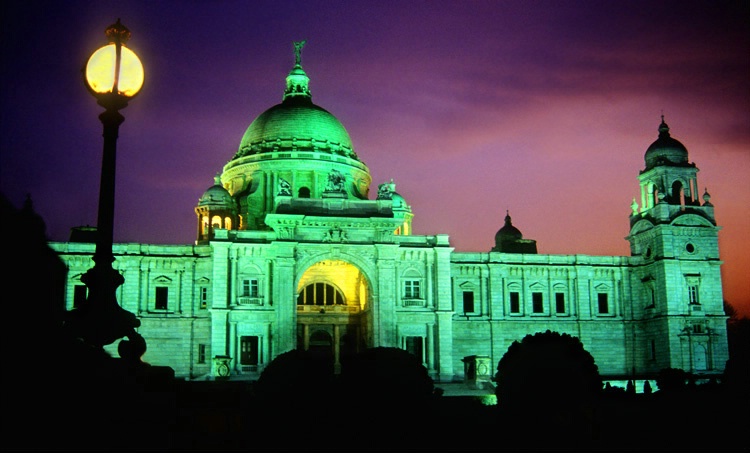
xmin=297 ymin=260 xmax=370 ymax=372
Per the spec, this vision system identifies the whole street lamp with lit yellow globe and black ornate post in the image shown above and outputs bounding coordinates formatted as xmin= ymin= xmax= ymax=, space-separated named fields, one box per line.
xmin=66 ymin=19 xmax=146 ymax=360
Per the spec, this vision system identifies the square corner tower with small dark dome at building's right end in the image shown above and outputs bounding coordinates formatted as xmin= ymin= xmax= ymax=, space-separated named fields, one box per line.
xmin=627 ymin=116 xmax=728 ymax=375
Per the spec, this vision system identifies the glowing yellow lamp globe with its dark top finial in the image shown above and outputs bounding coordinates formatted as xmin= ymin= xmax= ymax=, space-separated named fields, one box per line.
xmin=84 ymin=19 xmax=144 ymax=103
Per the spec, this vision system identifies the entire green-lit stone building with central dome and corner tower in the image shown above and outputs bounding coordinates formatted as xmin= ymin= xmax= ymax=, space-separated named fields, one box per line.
xmin=51 ymin=42 xmax=728 ymax=390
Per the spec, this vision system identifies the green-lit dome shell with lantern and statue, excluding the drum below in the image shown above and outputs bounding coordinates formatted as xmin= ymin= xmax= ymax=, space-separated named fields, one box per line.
xmin=232 ymin=41 xmax=358 ymax=159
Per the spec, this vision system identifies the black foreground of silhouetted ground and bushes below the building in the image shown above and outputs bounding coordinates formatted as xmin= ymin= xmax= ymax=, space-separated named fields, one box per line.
xmin=0 ymin=195 xmax=750 ymax=452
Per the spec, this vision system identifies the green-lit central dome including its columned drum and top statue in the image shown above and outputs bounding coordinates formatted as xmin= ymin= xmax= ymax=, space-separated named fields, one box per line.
xmin=221 ymin=41 xmax=372 ymax=230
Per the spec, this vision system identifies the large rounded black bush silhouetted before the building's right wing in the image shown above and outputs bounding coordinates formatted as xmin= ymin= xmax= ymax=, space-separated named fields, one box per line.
xmin=495 ymin=330 xmax=602 ymax=451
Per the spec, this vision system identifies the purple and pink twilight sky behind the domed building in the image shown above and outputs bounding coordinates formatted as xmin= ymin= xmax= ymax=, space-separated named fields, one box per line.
xmin=0 ymin=0 xmax=750 ymax=316
